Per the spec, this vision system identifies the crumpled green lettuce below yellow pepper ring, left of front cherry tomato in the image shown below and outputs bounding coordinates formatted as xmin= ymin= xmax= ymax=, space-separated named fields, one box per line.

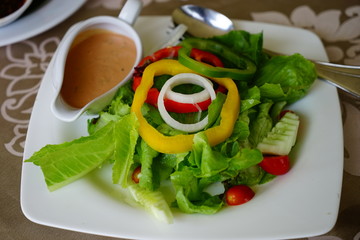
xmin=170 ymin=132 xmax=262 ymax=214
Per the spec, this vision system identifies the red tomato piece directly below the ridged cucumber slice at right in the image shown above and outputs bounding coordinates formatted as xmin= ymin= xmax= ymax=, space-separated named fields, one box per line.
xmin=259 ymin=155 xmax=290 ymax=175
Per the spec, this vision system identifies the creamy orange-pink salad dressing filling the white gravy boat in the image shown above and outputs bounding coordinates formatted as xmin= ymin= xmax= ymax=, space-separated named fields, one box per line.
xmin=61 ymin=29 xmax=136 ymax=108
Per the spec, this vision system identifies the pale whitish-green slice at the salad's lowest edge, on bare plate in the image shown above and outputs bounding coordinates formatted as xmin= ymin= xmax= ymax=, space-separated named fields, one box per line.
xmin=128 ymin=184 xmax=173 ymax=224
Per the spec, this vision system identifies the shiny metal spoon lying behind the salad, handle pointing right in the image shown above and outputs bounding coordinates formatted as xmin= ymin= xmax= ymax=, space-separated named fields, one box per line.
xmin=172 ymin=4 xmax=360 ymax=97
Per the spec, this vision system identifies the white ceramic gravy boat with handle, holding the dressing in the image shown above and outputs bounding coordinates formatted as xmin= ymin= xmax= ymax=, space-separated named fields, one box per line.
xmin=51 ymin=0 xmax=142 ymax=122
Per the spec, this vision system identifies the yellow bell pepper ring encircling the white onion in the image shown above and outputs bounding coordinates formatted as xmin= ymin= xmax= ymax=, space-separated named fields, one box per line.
xmin=131 ymin=59 xmax=240 ymax=154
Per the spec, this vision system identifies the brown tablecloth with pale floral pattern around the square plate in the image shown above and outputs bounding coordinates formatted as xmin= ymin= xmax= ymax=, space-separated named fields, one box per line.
xmin=0 ymin=0 xmax=360 ymax=240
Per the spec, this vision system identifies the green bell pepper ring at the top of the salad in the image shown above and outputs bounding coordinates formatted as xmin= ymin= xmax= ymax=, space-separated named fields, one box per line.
xmin=178 ymin=38 xmax=256 ymax=81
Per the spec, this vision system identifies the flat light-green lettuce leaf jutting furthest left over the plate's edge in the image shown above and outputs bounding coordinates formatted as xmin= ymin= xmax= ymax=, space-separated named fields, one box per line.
xmin=26 ymin=122 xmax=116 ymax=191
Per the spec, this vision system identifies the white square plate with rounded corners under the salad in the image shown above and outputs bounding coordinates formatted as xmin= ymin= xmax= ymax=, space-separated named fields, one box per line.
xmin=21 ymin=17 xmax=343 ymax=240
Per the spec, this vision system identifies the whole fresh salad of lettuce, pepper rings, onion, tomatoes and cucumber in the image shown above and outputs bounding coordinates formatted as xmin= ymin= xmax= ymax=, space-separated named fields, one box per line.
xmin=26 ymin=31 xmax=317 ymax=223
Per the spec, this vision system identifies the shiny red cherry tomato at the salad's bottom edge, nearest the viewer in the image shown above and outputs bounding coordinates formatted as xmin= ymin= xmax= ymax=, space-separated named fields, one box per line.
xmin=225 ymin=185 xmax=255 ymax=206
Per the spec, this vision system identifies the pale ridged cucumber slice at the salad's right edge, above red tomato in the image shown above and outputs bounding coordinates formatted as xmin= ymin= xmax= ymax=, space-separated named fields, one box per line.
xmin=257 ymin=112 xmax=300 ymax=155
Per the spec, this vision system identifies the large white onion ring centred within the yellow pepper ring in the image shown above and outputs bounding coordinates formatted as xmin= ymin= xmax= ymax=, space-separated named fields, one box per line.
xmin=157 ymin=73 xmax=216 ymax=132
